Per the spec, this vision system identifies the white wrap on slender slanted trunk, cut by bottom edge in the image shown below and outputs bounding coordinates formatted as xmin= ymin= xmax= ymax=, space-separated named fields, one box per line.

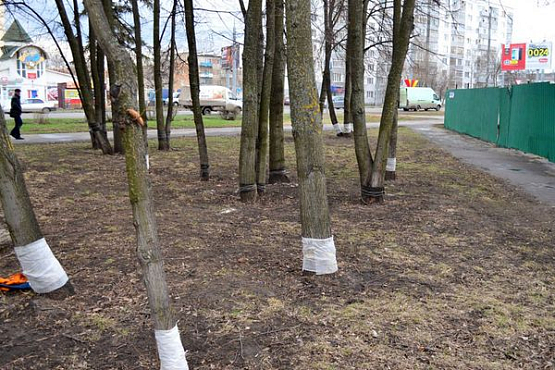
xmin=154 ymin=325 xmax=189 ymax=370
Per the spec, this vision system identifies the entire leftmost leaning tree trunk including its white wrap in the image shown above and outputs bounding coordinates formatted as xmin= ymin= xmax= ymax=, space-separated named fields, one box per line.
xmin=0 ymin=108 xmax=74 ymax=298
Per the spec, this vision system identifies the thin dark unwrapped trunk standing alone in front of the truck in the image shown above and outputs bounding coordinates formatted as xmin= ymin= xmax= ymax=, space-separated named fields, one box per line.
xmin=184 ymin=0 xmax=210 ymax=181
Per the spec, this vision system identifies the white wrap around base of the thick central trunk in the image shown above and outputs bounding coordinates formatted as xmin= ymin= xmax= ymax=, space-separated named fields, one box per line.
xmin=303 ymin=236 xmax=337 ymax=275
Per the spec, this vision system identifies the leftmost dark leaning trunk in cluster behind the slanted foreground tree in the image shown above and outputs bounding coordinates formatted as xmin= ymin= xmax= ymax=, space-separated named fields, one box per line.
xmin=55 ymin=0 xmax=113 ymax=154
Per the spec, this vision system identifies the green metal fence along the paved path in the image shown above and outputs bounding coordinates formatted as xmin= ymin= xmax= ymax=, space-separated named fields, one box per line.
xmin=445 ymin=83 xmax=555 ymax=162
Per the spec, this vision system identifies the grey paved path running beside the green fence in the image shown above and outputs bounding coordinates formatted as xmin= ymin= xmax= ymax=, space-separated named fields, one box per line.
xmin=411 ymin=125 xmax=555 ymax=207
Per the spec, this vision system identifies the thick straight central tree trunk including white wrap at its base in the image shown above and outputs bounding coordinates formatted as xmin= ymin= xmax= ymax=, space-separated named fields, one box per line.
xmin=286 ymin=0 xmax=337 ymax=274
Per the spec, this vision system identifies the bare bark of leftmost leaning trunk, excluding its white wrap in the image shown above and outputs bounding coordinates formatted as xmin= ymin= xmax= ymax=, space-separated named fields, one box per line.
xmin=0 ymin=108 xmax=74 ymax=298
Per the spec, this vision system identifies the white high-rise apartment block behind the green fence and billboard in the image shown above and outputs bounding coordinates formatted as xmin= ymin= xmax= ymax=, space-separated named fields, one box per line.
xmin=406 ymin=0 xmax=513 ymax=95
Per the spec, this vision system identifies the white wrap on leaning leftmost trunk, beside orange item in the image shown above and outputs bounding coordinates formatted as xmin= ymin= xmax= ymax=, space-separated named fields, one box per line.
xmin=14 ymin=238 xmax=69 ymax=293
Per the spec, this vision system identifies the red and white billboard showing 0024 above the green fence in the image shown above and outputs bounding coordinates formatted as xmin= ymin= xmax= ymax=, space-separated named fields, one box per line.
xmin=501 ymin=42 xmax=552 ymax=71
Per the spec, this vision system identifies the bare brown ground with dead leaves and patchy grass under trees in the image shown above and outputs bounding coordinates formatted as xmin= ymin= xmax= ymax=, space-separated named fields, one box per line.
xmin=0 ymin=129 xmax=555 ymax=370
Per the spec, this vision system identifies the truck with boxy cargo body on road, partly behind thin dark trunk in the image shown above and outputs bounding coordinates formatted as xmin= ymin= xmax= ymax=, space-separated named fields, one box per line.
xmin=179 ymin=85 xmax=243 ymax=120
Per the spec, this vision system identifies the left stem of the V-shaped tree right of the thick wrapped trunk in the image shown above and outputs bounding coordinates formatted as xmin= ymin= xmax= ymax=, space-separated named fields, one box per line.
xmin=347 ymin=0 xmax=372 ymax=189
